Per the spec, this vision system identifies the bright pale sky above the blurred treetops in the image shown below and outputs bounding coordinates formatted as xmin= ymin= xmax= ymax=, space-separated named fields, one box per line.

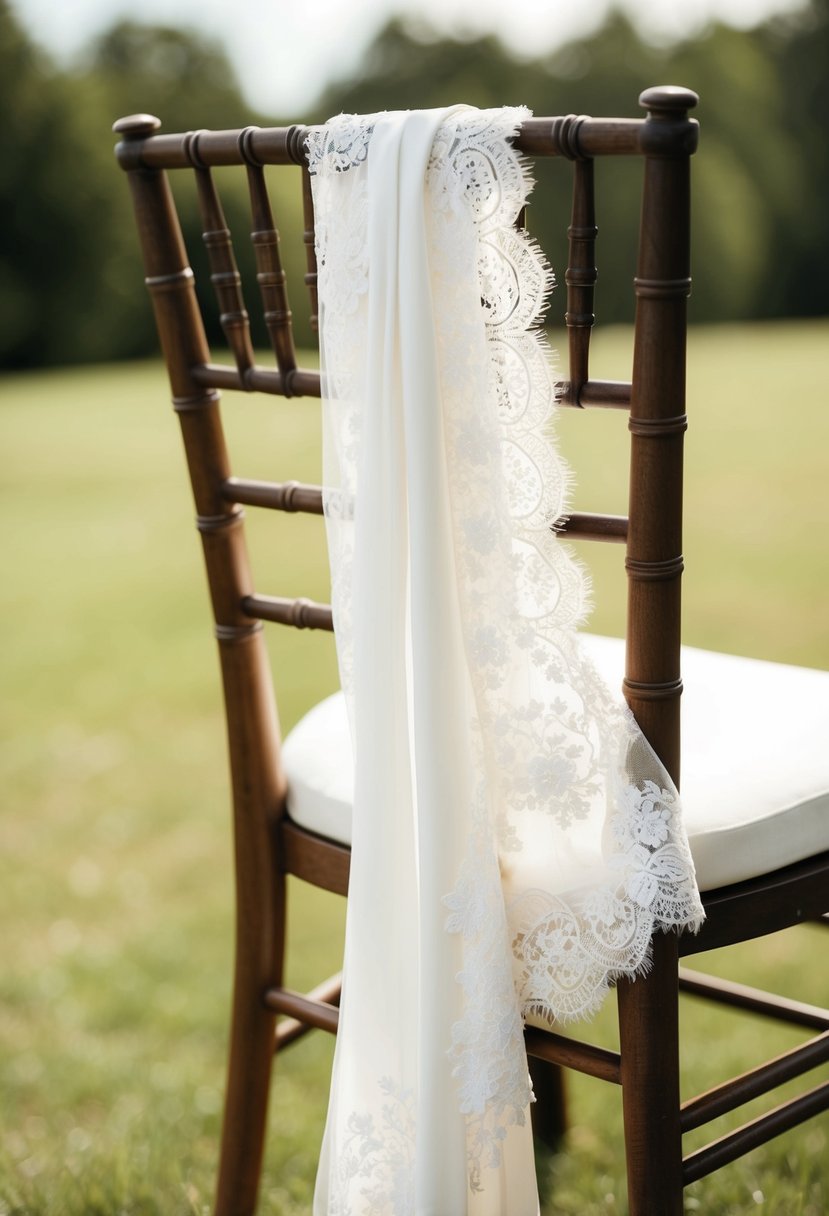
xmin=11 ymin=0 xmax=802 ymax=118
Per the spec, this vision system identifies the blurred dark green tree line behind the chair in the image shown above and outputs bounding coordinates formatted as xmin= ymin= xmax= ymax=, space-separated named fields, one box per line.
xmin=0 ymin=0 xmax=829 ymax=367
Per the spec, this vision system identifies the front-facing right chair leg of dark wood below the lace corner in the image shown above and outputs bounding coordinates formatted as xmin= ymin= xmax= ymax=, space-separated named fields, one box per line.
xmin=617 ymin=933 xmax=683 ymax=1216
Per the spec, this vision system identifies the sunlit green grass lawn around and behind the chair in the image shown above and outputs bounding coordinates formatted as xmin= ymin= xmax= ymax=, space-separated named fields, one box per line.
xmin=0 ymin=322 xmax=829 ymax=1216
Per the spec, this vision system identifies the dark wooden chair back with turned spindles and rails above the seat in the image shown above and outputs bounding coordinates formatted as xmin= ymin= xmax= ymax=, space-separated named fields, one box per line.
xmin=115 ymin=88 xmax=698 ymax=784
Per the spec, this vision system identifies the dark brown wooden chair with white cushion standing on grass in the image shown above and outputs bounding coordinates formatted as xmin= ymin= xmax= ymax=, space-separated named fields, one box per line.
xmin=114 ymin=88 xmax=829 ymax=1216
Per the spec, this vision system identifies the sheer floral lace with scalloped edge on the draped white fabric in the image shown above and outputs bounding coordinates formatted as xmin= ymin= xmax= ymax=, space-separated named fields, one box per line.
xmin=309 ymin=108 xmax=703 ymax=1216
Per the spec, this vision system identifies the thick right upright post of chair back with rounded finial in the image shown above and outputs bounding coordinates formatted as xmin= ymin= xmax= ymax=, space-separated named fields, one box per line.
xmin=624 ymin=88 xmax=698 ymax=784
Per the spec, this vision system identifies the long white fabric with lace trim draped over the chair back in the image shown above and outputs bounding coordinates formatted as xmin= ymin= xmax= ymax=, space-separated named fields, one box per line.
xmin=309 ymin=106 xmax=701 ymax=1216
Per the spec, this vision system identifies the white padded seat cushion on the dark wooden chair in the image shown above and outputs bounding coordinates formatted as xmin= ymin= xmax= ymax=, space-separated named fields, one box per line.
xmin=283 ymin=634 xmax=829 ymax=891
